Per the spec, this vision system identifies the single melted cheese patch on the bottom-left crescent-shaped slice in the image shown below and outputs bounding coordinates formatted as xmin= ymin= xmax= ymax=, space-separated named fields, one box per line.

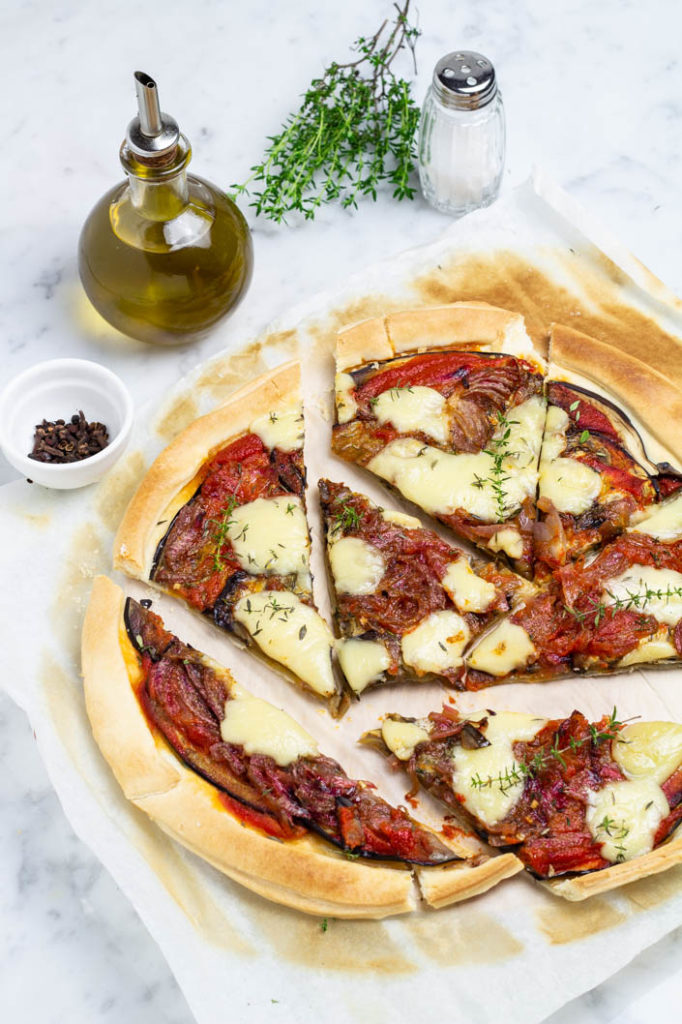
xmin=220 ymin=687 xmax=318 ymax=767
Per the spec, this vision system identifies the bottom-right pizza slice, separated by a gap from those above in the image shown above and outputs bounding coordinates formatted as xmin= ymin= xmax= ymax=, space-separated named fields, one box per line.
xmin=365 ymin=706 xmax=682 ymax=900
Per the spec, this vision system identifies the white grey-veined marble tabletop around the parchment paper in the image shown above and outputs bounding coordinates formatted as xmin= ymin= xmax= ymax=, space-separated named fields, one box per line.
xmin=0 ymin=0 xmax=682 ymax=1024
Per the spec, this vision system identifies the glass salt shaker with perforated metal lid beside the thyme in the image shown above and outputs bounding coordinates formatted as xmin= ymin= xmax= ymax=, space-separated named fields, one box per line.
xmin=419 ymin=50 xmax=505 ymax=217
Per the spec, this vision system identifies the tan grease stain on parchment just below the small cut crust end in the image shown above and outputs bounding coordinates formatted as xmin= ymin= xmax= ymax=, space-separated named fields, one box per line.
xmin=406 ymin=907 xmax=523 ymax=967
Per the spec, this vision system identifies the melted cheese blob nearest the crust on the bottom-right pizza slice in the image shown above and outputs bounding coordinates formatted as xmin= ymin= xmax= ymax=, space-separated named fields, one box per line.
xmin=586 ymin=778 xmax=670 ymax=862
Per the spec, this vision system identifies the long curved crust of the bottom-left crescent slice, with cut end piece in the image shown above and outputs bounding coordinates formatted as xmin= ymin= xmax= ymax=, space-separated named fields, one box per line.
xmin=82 ymin=577 xmax=506 ymax=918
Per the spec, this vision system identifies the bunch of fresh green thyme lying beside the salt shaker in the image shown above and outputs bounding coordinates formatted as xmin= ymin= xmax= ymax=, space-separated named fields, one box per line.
xmin=232 ymin=0 xmax=420 ymax=223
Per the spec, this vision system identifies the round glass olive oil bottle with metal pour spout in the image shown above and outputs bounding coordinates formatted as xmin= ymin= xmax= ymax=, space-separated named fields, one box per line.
xmin=79 ymin=72 xmax=253 ymax=345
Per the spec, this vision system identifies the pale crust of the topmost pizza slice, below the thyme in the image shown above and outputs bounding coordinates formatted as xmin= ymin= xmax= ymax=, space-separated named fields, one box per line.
xmin=336 ymin=302 xmax=544 ymax=372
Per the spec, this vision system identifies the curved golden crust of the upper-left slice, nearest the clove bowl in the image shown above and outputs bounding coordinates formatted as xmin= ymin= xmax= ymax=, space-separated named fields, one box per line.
xmin=114 ymin=362 xmax=300 ymax=580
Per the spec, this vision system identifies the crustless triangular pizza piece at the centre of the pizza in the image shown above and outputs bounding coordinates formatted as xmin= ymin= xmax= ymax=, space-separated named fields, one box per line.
xmin=319 ymin=480 xmax=535 ymax=694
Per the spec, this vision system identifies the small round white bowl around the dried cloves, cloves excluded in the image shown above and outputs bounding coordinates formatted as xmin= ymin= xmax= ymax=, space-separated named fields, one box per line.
xmin=0 ymin=359 xmax=133 ymax=490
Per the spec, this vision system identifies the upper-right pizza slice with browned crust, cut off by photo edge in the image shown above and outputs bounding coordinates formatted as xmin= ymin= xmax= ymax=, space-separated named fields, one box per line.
xmin=535 ymin=325 xmax=682 ymax=570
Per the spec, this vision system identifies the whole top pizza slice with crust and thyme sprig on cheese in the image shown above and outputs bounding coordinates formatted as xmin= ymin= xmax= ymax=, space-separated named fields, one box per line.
xmin=332 ymin=302 xmax=545 ymax=577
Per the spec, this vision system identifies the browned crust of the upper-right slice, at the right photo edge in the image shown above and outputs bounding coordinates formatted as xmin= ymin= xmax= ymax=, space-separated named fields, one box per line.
xmin=550 ymin=324 xmax=682 ymax=462
